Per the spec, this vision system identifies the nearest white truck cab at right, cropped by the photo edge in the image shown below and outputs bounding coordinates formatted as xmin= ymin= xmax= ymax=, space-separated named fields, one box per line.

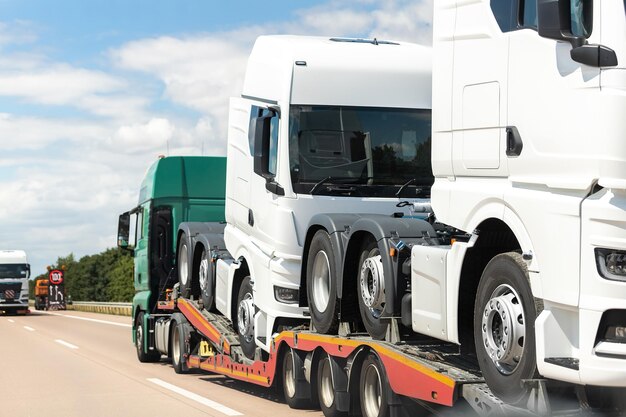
xmin=412 ymin=0 xmax=626 ymax=402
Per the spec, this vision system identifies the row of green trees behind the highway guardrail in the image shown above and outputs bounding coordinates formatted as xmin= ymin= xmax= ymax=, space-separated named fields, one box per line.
xmin=30 ymin=248 xmax=135 ymax=302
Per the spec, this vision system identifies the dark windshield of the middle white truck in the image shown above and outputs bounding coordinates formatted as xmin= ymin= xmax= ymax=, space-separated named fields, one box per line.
xmin=289 ymin=106 xmax=433 ymax=197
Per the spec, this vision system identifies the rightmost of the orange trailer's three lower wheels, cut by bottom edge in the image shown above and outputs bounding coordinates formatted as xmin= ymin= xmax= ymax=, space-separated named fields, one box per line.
xmin=359 ymin=353 xmax=389 ymax=417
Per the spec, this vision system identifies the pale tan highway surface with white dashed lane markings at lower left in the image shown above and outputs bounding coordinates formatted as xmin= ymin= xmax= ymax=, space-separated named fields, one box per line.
xmin=0 ymin=311 xmax=322 ymax=417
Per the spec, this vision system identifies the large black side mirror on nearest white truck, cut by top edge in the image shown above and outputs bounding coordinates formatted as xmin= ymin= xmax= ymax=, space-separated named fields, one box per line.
xmin=537 ymin=0 xmax=586 ymax=48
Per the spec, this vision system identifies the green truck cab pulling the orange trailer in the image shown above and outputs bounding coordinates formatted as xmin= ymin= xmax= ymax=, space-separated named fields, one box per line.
xmin=117 ymin=156 xmax=226 ymax=362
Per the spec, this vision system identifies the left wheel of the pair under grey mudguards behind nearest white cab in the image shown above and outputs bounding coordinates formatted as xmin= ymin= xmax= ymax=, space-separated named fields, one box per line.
xmin=306 ymin=230 xmax=339 ymax=334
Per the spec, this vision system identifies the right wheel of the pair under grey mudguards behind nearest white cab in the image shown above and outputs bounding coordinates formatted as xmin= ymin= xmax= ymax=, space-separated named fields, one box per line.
xmin=357 ymin=241 xmax=389 ymax=340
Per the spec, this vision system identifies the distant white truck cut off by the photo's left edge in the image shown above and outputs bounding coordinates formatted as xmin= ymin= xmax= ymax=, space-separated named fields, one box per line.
xmin=0 ymin=250 xmax=30 ymax=314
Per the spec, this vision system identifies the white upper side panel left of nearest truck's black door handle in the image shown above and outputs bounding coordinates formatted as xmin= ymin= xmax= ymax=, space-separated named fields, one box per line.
xmin=452 ymin=0 xmax=514 ymax=177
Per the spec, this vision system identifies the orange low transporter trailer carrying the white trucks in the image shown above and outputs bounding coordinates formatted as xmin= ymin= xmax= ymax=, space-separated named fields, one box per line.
xmin=148 ymin=286 xmax=604 ymax=417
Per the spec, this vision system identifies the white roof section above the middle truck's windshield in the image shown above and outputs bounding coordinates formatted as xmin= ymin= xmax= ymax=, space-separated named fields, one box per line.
xmin=242 ymin=35 xmax=432 ymax=108
